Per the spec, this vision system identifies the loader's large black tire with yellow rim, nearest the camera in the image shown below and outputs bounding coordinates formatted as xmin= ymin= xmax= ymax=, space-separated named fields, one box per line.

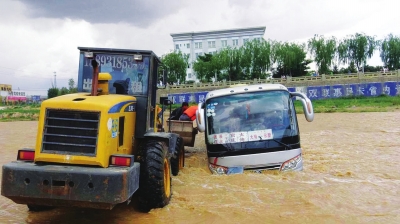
xmin=138 ymin=140 xmax=172 ymax=212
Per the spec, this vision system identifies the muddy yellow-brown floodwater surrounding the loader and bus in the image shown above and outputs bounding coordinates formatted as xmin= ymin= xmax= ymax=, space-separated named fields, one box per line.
xmin=0 ymin=111 xmax=400 ymax=224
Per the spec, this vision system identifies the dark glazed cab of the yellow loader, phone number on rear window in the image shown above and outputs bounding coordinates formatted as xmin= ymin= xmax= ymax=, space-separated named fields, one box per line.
xmin=77 ymin=47 xmax=161 ymax=138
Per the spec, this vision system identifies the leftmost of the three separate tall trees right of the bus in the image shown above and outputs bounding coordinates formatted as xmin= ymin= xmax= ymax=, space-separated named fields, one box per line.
xmin=308 ymin=35 xmax=336 ymax=74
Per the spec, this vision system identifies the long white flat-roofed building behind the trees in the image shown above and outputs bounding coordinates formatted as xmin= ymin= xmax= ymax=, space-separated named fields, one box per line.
xmin=171 ymin=26 xmax=265 ymax=81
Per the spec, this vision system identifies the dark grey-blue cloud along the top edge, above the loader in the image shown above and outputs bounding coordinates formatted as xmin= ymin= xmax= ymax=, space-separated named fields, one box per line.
xmin=14 ymin=0 xmax=186 ymax=28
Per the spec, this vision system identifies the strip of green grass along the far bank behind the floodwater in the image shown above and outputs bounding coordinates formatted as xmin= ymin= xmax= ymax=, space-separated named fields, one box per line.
xmin=0 ymin=95 xmax=400 ymax=121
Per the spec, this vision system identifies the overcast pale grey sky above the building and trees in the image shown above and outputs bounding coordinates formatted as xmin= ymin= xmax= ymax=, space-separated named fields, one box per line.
xmin=0 ymin=0 xmax=400 ymax=91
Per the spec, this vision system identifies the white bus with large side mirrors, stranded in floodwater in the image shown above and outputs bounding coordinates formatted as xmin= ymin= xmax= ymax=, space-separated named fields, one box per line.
xmin=196 ymin=84 xmax=314 ymax=174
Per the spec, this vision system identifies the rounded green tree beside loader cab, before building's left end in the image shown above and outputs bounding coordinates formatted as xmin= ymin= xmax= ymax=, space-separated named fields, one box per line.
xmin=161 ymin=51 xmax=189 ymax=83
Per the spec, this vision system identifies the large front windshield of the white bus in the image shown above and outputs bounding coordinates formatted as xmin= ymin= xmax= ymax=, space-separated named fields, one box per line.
xmin=206 ymin=90 xmax=298 ymax=144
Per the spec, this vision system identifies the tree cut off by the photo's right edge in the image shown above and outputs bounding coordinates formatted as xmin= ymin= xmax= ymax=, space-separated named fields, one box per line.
xmin=380 ymin=34 xmax=400 ymax=70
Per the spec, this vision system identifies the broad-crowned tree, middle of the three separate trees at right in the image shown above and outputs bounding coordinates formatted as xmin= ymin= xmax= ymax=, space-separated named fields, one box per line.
xmin=338 ymin=33 xmax=379 ymax=71
